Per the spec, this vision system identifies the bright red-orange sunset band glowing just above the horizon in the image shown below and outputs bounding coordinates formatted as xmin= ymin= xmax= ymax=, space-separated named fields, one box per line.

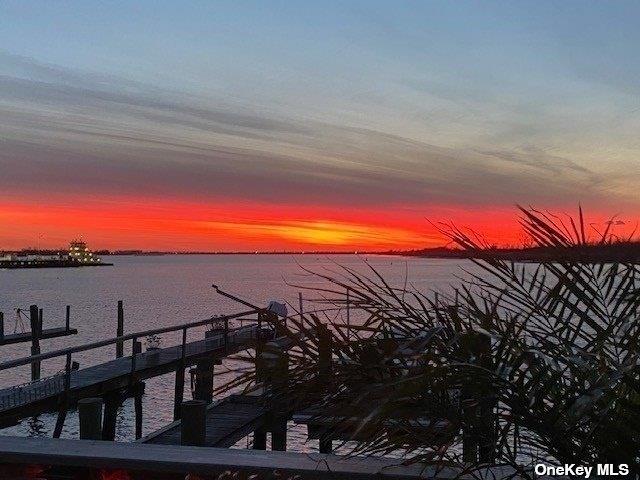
xmin=0 ymin=192 xmax=636 ymax=251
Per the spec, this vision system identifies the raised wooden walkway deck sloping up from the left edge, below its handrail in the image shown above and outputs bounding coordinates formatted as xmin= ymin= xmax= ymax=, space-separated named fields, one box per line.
xmin=0 ymin=325 xmax=266 ymax=418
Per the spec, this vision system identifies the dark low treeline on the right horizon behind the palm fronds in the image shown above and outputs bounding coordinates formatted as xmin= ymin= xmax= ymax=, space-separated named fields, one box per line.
xmin=387 ymin=241 xmax=640 ymax=263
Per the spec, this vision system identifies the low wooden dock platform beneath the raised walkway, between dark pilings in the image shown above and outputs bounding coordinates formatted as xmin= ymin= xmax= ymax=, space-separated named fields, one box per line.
xmin=138 ymin=395 xmax=267 ymax=448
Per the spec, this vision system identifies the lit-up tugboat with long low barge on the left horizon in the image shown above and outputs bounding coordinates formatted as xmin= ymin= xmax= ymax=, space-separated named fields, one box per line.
xmin=0 ymin=240 xmax=113 ymax=269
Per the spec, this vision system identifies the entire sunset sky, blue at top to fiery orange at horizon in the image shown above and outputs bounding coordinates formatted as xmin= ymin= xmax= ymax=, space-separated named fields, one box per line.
xmin=0 ymin=0 xmax=640 ymax=251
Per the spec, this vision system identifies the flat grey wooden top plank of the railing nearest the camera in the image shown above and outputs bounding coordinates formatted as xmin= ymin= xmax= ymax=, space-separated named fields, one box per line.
xmin=0 ymin=437 xmax=480 ymax=480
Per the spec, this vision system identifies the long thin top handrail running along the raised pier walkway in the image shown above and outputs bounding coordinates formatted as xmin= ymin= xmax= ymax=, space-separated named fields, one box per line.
xmin=0 ymin=308 xmax=264 ymax=371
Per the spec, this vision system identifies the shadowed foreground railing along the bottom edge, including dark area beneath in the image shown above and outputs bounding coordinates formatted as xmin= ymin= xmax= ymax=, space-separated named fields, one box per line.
xmin=0 ymin=437 xmax=507 ymax=480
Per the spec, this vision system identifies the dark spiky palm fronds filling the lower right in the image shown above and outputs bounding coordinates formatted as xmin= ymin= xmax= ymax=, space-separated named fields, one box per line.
xmin=225 ymin=208 xmax=640 ymax=478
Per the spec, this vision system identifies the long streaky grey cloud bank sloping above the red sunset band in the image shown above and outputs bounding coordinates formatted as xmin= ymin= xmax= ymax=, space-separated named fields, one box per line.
xmin=0 ymin=54 xmax=627 ymax=213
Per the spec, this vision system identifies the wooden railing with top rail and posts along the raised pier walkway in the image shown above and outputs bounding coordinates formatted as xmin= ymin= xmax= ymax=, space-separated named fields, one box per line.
xmin=0 ymin=308 xmax=277 ymax=411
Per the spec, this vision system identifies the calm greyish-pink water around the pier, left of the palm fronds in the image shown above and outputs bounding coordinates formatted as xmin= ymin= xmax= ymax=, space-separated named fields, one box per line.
xmin=0 ymin=255 xmax=465 ymax=451
